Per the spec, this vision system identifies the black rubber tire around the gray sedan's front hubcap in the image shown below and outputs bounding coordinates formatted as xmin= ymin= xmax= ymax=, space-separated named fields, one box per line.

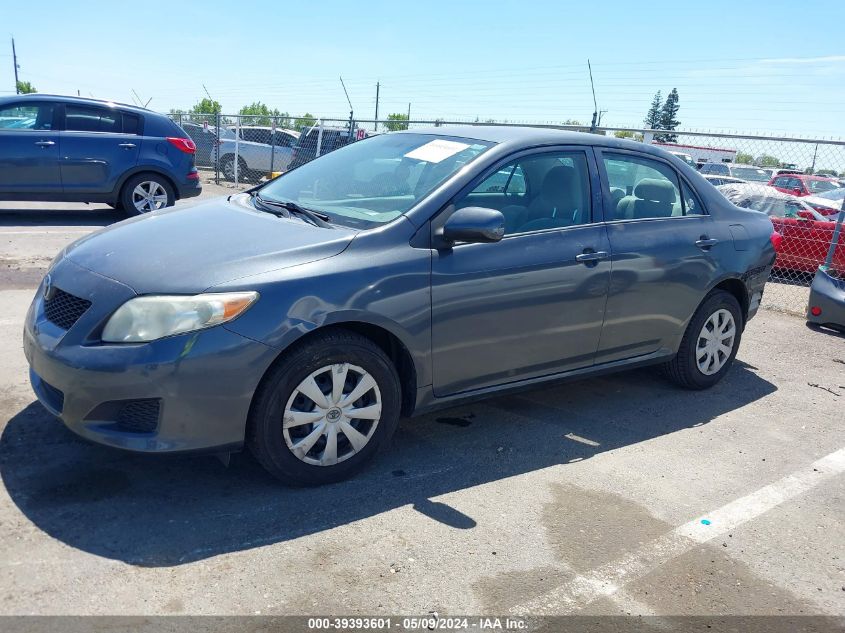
xmin=246 ymin=329 xmax=401 ymax=486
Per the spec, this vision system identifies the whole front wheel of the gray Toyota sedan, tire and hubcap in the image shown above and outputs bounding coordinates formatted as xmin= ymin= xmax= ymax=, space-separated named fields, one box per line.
xmin=247 ymin=330 xmax=401 ymax=486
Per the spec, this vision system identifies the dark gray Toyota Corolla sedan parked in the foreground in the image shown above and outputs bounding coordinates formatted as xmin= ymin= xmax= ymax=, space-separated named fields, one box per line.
xmin=24 ymin=126 xmax=775 ymax=484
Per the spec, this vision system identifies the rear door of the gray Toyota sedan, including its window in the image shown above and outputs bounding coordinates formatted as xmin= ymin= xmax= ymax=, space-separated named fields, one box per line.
xmin=596 ymin=150 xmax=733 ymax=363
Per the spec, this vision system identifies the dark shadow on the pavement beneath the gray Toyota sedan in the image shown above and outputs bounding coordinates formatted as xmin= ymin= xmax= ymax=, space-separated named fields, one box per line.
xmin=0 ymin=362 xmax=776 ymax=567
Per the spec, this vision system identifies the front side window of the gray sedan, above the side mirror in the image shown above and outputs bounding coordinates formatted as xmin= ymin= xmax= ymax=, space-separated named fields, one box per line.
xmin=455 ymin=152 xmax=591 ymax=235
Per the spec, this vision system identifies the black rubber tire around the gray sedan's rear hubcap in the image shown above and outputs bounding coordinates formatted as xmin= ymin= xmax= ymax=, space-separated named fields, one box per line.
xmin=663 ymin=290 xmax=743 ymax=390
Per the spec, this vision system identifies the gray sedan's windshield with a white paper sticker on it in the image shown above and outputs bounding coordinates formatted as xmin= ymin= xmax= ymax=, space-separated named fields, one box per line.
xmin=261 ymin=133 xmax=492 ymax=228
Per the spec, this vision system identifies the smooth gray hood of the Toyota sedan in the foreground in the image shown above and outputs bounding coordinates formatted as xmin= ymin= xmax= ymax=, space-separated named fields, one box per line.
xmin=64 ymin=194 xmax=356 ymax=294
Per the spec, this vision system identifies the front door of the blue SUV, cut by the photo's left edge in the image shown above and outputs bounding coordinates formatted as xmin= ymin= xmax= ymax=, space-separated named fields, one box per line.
xmin=0 ymin=99 xmax=62 ymax=195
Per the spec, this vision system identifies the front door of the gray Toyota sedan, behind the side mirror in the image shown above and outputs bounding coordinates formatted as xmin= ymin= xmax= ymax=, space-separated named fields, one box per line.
xmin=431 ymin=147 xmax=610 ymax=397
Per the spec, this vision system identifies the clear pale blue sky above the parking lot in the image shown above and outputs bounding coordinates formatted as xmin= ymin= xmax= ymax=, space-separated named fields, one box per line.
xmin=0 ymin=0 xmax=845 ymax=138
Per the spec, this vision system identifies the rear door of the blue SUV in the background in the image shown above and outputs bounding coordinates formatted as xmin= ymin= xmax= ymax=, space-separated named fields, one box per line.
xmin=59 ymin=103 xmax=141 ymax=195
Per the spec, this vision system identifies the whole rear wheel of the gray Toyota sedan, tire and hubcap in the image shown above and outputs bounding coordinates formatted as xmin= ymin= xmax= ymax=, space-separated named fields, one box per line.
xmin=664 ymin=290 xmax=742 ymax=389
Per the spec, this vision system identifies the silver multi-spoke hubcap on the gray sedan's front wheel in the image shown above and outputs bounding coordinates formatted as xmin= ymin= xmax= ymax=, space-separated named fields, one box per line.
xmin=282 ymin=363 xmax=381 ymax=466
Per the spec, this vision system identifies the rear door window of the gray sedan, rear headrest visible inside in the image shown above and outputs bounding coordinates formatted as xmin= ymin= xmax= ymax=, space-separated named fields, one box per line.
xmin=602 ymin=154 xmax=688 ymax=220
